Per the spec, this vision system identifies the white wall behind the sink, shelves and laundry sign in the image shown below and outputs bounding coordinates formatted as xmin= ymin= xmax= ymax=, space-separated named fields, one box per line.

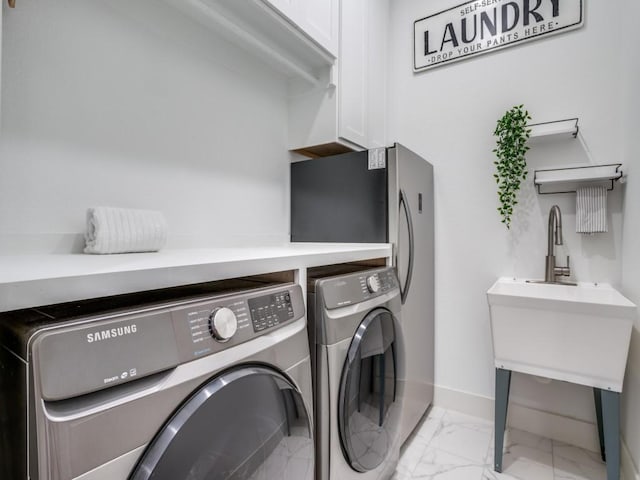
xmin=389 ymin=0 xmax=623 ymax=422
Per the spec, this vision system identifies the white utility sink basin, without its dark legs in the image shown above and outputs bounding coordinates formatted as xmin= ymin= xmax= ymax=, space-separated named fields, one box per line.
xmin=487 ymin=278 xmax=636 ymax=392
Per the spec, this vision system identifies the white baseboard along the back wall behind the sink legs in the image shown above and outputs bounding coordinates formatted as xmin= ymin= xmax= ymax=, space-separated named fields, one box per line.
xmin=433 ymin=386 xmax=600 ymax=452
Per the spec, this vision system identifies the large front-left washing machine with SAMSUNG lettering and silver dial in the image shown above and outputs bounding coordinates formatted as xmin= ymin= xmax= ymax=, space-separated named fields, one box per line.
xmin=0 ymin=284 xmax=314 ymax=480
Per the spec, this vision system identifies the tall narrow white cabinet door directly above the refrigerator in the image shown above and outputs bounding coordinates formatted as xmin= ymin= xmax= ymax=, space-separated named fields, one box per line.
xmin=338 ymin=0 xmax=369 ymax=148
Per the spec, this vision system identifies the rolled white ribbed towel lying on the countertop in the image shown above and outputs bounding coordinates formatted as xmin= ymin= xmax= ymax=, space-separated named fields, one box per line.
xmin=84 ymin=207 xmax=167 ymax=253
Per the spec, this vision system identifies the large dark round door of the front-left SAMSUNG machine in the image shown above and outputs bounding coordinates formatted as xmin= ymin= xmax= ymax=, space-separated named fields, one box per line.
xmin=129 ymin=366 xmax=314 ymax=480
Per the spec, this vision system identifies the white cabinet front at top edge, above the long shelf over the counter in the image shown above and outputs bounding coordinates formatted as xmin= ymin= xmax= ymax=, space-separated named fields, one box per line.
xmin=258 ymin=0 xmax=340 ymax=57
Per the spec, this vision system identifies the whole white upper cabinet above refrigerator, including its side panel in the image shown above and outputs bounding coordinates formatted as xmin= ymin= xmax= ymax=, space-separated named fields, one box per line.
xmin=290 ymin=0 xmax=389 ymax=156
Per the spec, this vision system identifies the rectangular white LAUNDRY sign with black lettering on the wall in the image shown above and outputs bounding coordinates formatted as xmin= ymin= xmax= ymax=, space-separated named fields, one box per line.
xmin=413 ymin=0 xmax=584 ymax=72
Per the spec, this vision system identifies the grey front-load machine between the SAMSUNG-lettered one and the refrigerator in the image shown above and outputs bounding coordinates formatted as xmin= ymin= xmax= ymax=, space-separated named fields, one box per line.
xmin=307 ymin=266 xmax=404 ymax=480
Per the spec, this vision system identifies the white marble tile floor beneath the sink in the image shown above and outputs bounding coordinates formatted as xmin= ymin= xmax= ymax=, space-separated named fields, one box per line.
xmin=392 ymin=407 xmax=606 ymax=480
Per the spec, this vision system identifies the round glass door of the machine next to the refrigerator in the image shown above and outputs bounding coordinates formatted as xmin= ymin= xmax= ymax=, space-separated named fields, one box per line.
xmin=338 ymin=308 xmax=399 ymax=472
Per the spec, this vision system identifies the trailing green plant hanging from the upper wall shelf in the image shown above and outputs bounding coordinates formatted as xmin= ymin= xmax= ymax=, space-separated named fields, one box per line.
xmin=493 ymin=105 xmax=531 ymax=228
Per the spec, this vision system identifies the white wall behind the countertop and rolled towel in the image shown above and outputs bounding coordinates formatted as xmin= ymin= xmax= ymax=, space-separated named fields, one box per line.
xmin=0 ymin=0 xmax=289 ymax=253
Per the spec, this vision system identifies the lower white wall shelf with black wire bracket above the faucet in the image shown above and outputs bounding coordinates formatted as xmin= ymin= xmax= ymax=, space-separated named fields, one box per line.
xmin=533 ymin=163 xmax=623 ymax=194
